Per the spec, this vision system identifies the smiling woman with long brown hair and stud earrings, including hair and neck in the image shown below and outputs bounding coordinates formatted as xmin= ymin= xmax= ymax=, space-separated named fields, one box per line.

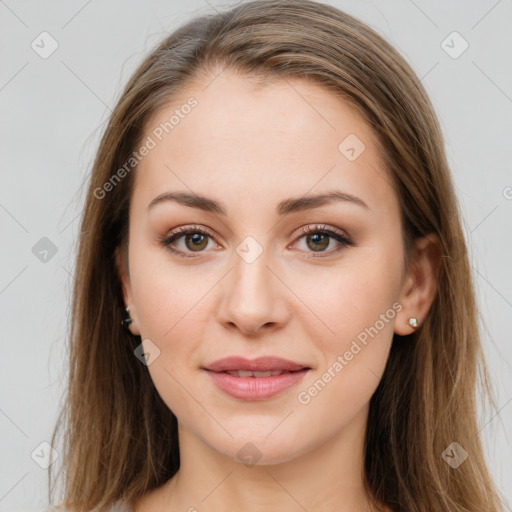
xmin=50 ymin=0 xmax=500 ymax=512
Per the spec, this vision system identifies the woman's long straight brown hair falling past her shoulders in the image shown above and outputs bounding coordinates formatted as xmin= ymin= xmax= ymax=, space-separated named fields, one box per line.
xmin=49 ymin=0 xmax=501 ymax=512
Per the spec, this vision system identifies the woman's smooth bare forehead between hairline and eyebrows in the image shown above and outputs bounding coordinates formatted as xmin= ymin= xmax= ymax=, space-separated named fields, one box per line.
xmin=134 ymin=70 xmax=396 ymax=216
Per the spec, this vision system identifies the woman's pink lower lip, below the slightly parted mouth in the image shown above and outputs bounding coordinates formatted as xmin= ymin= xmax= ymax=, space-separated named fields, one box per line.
xmin=205 ymin=369 xmax=309 ymax=400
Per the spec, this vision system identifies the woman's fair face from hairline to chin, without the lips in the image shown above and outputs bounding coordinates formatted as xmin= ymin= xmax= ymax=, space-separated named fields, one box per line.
xmin=116 ymin=71 xmax=428 ymax=464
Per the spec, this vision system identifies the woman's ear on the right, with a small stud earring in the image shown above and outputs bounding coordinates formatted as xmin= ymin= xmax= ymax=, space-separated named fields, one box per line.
xmin=395 ymin=233 xmax=441 ymax=336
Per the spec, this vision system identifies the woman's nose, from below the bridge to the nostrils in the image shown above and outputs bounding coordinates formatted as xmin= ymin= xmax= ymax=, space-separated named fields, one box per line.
xmin=217 ymin=247 xmax=289 ymax=336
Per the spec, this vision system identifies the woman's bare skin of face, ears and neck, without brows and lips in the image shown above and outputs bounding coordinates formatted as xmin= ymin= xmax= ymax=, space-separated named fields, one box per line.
xmin=117 ymin=70 xmax=436 ymax=512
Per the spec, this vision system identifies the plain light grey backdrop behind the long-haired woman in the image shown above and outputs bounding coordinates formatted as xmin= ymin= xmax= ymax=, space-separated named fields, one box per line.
xmin=0 ymin=0 xmax=512 ymax=511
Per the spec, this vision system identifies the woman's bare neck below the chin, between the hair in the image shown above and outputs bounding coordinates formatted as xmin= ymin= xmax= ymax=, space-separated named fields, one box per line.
xmin=136 ymin=407 xmax=386 ymax=512
